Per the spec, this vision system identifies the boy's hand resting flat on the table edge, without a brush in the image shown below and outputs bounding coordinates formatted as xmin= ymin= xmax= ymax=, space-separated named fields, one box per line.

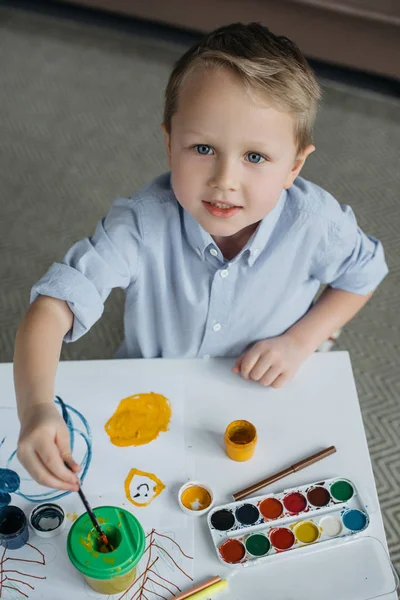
xmin=232 ymin=333 xmax=311 ymax=388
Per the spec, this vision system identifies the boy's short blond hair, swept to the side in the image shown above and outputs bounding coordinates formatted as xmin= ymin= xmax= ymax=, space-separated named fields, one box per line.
xmin=164 ymin=23 xmax=321 ymax=151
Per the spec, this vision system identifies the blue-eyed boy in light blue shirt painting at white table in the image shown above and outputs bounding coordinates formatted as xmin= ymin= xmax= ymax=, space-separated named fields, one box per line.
xmin=14 ymin=23 xmax=387 ymax=490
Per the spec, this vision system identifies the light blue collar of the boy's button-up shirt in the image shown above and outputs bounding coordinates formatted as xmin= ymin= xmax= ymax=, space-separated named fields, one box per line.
xmin=182 ymin=190 xmax=287 ymax=266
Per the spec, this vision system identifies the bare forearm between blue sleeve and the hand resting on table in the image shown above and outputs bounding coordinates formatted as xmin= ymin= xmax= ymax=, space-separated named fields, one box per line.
xmin=285 ymin=287 xmax=374 ymax=354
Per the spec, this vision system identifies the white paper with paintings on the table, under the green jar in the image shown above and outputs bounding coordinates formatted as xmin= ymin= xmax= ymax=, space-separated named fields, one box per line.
xmin=0 ymin=363 xmax=194 ymax=600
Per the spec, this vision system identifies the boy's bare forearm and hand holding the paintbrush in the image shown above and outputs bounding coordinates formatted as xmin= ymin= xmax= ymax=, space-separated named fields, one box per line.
xmin=14 ymin=296 xmax=79 ymax=489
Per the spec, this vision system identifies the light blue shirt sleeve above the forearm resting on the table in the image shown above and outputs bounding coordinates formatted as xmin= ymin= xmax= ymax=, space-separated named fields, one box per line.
xmin=314 ymin=206 xmax=388 ymax=295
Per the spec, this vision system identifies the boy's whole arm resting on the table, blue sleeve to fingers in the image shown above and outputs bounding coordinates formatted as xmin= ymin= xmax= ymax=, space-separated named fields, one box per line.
xmin=233 ymin=190 xmax=388 ymax=387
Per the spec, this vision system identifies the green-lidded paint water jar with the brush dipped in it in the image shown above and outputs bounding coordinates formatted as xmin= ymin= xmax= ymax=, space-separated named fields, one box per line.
xmin=67 ymin=506 xmax=145 ymax=594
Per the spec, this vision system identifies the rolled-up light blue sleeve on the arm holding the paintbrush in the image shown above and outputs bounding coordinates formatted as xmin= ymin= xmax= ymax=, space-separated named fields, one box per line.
xmin=30 ymin=199 xmax=141 ymax=342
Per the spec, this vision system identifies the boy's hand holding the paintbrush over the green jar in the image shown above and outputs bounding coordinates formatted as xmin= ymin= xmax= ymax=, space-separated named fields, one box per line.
xmin=17 ymin=403 xmax=80 ymax=492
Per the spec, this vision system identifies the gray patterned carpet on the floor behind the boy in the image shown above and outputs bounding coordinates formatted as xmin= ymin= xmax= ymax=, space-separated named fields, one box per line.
xmin=0 ymin=3 xmax=400 ymax=569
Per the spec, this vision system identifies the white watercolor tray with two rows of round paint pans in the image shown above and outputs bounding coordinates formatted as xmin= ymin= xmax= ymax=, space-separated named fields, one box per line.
xmin=207 ymin=478 xmax=369 ymax=568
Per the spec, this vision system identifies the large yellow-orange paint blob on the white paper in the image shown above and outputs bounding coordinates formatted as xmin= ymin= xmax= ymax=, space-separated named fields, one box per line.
xmin=105 ymin=392 xmax=171 ymax=446
